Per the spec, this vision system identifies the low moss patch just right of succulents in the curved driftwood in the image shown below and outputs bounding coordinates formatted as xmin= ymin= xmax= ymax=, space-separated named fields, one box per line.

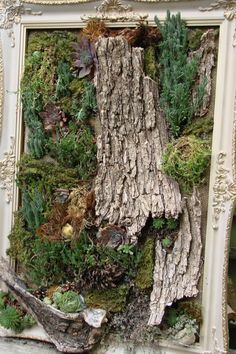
xmin=85 ymin=285 xmax=129 ymax=312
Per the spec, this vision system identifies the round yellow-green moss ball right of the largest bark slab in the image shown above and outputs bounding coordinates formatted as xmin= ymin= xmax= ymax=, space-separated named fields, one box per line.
xmin=163 ymin=135 xmax=211 ymax=192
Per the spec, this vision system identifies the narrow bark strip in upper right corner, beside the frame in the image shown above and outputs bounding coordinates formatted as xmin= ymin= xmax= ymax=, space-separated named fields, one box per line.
xmin=191 ymin=29 xmax=216 ymax=117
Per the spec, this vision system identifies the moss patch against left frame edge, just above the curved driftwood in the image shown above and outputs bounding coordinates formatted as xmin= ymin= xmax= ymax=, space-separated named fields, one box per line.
xmin=7 ymin=211 xmax=33 ymax=265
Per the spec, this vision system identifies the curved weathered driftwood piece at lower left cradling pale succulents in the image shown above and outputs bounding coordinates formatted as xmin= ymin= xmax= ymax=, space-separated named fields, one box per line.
xmin=0 ymin=258 xmax=103 ymax=353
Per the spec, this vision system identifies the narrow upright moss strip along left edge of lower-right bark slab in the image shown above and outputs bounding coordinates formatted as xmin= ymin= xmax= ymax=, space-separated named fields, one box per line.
xmin=135 ymin=238 xmax=155 ymax=289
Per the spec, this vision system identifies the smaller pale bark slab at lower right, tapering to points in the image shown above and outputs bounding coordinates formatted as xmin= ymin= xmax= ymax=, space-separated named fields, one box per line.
xmin=148 ymin=191 xmax=202 ymax=325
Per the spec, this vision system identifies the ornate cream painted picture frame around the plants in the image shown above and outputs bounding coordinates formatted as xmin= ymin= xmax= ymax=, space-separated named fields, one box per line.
xmin=0 ymin=0 xmax=236 ymax=354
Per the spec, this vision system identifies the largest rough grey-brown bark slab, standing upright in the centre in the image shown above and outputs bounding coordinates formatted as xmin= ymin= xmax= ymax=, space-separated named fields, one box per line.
xmin=95 ymin=37 xmax=181 ymax=238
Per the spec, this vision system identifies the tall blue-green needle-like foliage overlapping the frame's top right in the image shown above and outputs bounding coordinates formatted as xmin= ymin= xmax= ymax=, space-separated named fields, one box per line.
xmin=155 ymin=11 xmax=202 ymax=137
